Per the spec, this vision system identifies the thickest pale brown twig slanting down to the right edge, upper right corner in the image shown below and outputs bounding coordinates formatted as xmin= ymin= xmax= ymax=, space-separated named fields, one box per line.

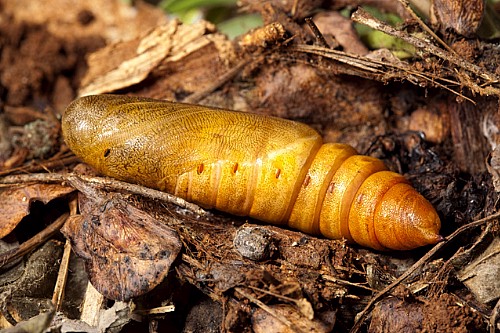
xmin=351 ymin=8 xmax=500 ymax=89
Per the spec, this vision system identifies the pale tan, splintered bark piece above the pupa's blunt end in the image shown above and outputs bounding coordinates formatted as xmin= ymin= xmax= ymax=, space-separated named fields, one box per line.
xmin=79 ymin=20 xmax=234 ymax=99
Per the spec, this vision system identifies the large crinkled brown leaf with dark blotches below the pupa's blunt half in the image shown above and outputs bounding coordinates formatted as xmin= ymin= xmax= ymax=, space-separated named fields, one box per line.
xmin=61 ymin=191 xmax=181 ymax=301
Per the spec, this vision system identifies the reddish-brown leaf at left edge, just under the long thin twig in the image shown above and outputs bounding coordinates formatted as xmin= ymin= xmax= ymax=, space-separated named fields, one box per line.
xmin=0 ymin=184 xmax=74 ymax=238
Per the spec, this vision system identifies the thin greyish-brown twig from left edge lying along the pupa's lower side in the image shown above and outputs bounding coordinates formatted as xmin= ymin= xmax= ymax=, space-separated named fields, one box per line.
xmin=0 ymin=173 xmax=205 ymax=216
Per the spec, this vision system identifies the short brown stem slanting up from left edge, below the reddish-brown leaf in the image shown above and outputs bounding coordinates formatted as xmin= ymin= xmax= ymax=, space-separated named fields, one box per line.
xmin=0 ymin=213 xmax=69 ymax=270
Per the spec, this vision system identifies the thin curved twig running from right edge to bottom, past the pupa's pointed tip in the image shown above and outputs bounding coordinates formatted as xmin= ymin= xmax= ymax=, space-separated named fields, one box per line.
xmin=349 ymin=212 xmax=500 ymax=333
